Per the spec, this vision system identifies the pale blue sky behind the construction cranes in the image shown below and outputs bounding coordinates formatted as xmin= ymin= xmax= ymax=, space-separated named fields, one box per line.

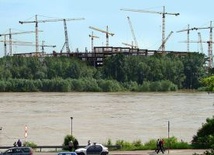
xmin=0 ymin=0 xmax=214 ymax=57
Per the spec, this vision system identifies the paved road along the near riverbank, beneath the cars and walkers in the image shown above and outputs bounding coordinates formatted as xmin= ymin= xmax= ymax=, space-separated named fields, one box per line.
xmin=34 ymin=149 xmax=205 ymax=155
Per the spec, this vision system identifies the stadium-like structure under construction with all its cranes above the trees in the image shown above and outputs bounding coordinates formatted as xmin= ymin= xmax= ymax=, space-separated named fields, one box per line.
xmin=0 ymin=6 xmax=213 ymax=68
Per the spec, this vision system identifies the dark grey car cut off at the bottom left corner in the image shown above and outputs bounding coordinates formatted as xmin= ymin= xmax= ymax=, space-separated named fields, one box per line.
xmin=0 ymin=147 xmax=33 ymax=155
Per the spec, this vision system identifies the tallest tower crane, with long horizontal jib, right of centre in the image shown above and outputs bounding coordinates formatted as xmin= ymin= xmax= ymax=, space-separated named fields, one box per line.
xmin=120 ymin=6 xmax=180 ymax=52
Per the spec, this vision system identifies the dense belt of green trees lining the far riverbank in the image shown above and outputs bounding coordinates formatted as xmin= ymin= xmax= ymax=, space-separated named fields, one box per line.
xmin=0 ymin=53 xmax=210 ymax=92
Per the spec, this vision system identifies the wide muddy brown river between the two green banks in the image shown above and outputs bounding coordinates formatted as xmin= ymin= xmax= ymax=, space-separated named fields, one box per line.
xmin=0 ymin=92 xmax=214 ymax=146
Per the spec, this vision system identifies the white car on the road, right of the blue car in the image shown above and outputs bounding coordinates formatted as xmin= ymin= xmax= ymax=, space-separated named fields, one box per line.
xmin=75 ymin=143 xmax=108 ymax=155
